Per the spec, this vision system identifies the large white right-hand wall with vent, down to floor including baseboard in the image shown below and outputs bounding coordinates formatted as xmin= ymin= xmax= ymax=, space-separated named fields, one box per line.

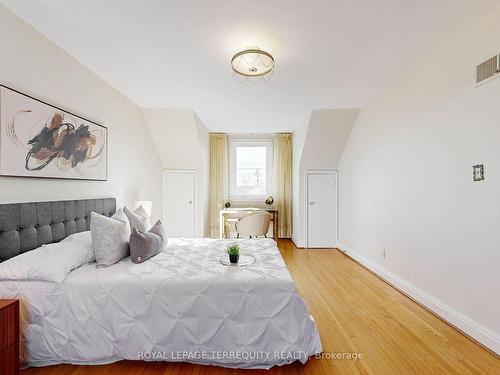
xmin=339 ymin=12 xmax=500 ymax=353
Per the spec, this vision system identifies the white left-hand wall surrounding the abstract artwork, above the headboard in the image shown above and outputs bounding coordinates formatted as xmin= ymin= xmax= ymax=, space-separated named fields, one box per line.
xmin=0 ymin=5 xmax=162 ymax=217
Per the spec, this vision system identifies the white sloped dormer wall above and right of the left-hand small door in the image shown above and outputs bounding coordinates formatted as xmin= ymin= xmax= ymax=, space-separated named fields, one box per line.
xmin=143 ymin=108 xmax=210 ymax=237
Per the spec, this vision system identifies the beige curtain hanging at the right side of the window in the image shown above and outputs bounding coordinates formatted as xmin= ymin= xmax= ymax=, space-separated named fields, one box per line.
xmin=274 ymin=133 xmax=292 ymax=238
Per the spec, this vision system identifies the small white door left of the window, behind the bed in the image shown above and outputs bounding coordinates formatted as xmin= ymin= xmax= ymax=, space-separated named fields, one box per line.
xmin=163 ymin=170 xmax=196 ymax=237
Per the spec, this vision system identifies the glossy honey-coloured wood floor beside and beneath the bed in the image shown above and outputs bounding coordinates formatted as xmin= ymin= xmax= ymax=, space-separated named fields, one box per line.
xmin=21 ymin=240 xmax=500 ymax=375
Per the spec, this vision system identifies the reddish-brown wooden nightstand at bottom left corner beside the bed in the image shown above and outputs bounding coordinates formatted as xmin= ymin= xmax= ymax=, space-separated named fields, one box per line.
xmin=0 ymin=299 xmax=19 ymax=375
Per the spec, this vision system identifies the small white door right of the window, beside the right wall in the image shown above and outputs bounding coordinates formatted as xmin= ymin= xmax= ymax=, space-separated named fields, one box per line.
xmin=306 ymin=171 xmax=337 ymax=248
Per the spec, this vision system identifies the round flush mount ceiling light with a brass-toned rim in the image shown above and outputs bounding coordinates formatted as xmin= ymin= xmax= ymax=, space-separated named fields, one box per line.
xmin=231 ymin=47 xmax=274 ymax=78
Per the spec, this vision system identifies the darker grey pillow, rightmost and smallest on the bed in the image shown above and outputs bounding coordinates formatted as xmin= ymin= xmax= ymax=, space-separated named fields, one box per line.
xmin=130 ymin=220 xmax=167 ymax=263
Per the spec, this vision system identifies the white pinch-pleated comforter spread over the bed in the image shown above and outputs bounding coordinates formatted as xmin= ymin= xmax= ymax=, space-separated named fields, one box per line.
xmin=0 ymin=239 xmax=322 ymax=368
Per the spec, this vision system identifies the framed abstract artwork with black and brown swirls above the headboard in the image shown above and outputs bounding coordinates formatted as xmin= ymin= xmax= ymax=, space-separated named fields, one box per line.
xmin=0 ymin=85 xmax=108 ymax=181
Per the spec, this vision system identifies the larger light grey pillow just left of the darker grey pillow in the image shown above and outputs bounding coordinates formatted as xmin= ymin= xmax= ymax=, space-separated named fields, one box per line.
xmin=90 ymin=208 xmax=130 ymax=267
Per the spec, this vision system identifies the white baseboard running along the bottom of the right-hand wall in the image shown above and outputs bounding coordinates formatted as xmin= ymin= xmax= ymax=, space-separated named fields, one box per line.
xmin=338 ymin=243 xmax=500 ymax=355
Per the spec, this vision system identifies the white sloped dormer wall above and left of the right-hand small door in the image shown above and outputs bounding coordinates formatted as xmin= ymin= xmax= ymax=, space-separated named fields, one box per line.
xmin=292 ymin=109 xmax=359 ymax=247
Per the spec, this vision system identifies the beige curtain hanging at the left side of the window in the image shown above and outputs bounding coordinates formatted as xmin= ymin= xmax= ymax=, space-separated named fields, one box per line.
xmin=209 ymin=133 xmax=229 ymax=238
